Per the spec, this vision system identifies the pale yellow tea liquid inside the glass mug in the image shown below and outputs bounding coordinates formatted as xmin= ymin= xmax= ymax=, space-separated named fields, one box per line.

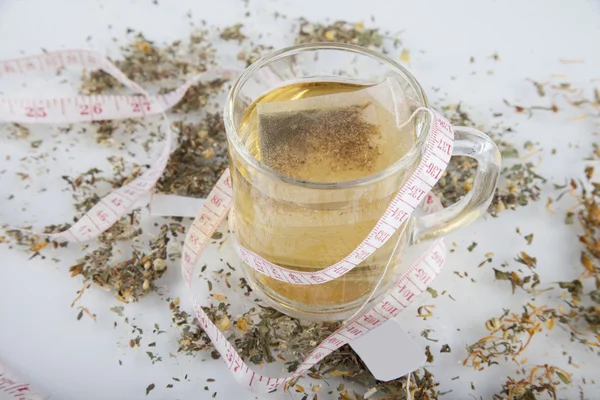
xmin=231 ymin=82 xmax=415 ymax=307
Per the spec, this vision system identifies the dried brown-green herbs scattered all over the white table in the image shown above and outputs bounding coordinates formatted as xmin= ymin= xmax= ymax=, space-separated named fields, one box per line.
xmin=0 ymin=14 xmax=600 ymax=400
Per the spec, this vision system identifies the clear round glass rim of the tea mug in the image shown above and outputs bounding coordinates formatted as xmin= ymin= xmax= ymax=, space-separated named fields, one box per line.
xmin=223 ymin=42 xmax=429 ymax=189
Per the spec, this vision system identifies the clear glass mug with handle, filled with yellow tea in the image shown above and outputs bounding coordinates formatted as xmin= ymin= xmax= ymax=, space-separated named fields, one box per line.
xmin=224 ymin=43 xmax=501 ymax=320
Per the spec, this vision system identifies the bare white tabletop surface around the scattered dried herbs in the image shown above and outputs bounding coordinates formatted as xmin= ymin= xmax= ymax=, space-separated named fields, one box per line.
xmin=0 ymin=0 xmax=600 ymax=400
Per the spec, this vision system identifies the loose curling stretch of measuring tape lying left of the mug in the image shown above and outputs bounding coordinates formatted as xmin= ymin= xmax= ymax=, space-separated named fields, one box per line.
xmin=0 ymin=50 xmax=236 ymax=242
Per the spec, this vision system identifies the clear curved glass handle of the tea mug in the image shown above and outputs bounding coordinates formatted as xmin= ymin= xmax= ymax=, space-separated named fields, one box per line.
xmin=410 ymin=126 xmax=502 ymax=244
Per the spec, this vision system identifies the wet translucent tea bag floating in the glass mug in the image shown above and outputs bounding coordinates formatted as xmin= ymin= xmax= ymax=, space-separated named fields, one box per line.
xmin=257 ymin=78 xmax=414 ymax=182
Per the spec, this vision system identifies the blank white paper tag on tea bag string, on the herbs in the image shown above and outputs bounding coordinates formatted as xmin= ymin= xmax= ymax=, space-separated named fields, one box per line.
xmin=350 ymin=319 xmax=426 ymax=382
